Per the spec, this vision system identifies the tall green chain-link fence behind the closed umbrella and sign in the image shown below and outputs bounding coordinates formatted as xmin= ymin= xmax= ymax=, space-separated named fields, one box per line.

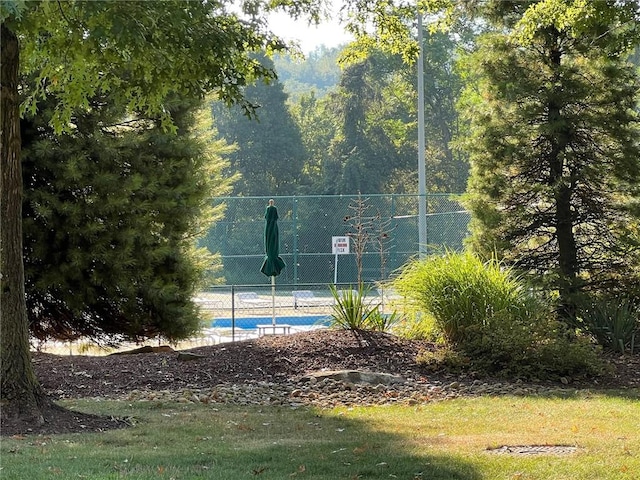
xmin=201 ymin=194 xmax=469 ymax=286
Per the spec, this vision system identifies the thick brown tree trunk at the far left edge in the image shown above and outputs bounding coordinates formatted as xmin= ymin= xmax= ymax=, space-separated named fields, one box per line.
xmin=0 ymin=23 xmax=46 ymax=425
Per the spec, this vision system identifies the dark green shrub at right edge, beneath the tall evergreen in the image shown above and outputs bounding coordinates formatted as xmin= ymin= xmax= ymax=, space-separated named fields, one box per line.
xmin=576 ymin=297 xmax=640 ymax=354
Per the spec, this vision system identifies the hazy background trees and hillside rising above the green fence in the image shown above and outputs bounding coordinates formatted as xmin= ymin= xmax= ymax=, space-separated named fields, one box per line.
xmin=213 ymin=26 xmax=473 ymax=196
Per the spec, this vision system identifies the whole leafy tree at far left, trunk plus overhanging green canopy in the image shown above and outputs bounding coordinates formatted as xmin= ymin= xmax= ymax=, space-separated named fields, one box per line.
xmin=0 ymin=0 xmax=320 ymax=432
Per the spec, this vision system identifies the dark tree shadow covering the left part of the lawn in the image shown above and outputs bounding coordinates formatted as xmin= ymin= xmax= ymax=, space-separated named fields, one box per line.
xmin=2 ymin=401 xmax=481 ymax=480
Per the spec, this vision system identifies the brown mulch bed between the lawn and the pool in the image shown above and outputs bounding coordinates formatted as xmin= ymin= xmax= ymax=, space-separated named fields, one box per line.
xmin=1 ymin=330 xmax=640 ymax=436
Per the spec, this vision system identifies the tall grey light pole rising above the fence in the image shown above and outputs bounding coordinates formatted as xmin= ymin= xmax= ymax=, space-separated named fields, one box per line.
xmin=418 ymin=7 xmax=427 ymax=258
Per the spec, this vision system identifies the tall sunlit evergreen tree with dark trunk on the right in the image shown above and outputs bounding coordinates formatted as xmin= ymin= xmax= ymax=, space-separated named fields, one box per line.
xmin=466 ymin=0 xmax=640 ymax=317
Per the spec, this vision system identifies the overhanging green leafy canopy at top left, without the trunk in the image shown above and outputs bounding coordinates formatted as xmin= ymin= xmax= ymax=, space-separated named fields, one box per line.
xmin=16 ymin=0 xmax=315 ymax=129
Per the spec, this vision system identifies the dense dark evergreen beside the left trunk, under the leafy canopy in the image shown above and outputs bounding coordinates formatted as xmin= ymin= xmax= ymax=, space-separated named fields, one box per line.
xmin=21 ymin=92 xmax=228 ymax=342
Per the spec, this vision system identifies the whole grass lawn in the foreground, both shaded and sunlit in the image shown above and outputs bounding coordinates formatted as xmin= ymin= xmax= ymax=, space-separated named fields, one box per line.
xmin=0 ymin=390 xmax=640 ymax=480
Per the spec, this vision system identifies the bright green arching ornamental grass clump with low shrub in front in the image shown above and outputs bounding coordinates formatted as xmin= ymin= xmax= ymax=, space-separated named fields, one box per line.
xmin=393 ymin=252 xmax=603 ymax=379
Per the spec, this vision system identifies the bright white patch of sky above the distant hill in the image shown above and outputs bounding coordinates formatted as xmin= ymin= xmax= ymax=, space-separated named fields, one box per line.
xmin=269 ymin=7 xmax=352 ymax=54
